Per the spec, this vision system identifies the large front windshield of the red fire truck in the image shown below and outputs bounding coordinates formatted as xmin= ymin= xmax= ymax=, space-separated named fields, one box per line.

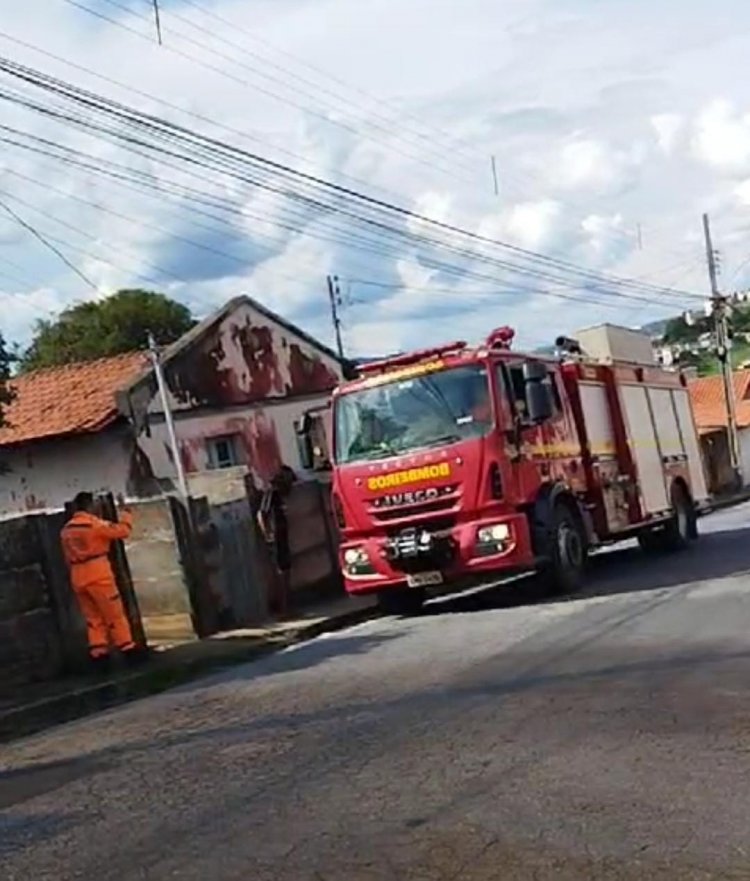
xmin=334 ymin=364 xmax=492 ymax=464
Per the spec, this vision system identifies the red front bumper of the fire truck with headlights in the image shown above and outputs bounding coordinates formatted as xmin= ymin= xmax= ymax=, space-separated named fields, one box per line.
xmin=339 ymin=513 xmax=534 ymax=594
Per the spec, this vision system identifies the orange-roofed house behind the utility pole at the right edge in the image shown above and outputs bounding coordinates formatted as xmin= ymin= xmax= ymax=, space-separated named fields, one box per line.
xmin=688 ymin=370 xmax=750 ymax=493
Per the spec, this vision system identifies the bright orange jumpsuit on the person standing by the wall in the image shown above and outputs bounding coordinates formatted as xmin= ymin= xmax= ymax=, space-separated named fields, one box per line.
xmin=61 ymin=511 xmax=136 ymax=658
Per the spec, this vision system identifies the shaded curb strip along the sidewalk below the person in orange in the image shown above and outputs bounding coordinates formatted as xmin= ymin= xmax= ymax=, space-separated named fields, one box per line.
xmin=0 ymin=606 xmax=377 ymax=743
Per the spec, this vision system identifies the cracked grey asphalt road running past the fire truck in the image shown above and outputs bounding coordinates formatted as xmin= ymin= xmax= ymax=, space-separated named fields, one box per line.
xmin=0 ymin=506 xmax=750 ymax=881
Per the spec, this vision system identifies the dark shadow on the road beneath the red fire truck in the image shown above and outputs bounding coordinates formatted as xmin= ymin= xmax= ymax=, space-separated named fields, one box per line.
xmin=425 ymin=528 xmax=750 ymax=615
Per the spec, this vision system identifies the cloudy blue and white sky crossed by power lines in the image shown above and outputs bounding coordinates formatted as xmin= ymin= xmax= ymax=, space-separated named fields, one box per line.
xmin=0 ymin=0 xmax=750 ymax=356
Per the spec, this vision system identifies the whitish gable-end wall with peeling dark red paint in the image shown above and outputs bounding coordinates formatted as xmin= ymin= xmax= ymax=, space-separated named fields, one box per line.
xmin=131 ymin=303 xmax=342 ymax=502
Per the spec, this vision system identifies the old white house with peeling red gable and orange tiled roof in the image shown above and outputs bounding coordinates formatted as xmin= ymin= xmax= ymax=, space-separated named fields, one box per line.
xmin=0 ymin=297 xmax=343 ymax=515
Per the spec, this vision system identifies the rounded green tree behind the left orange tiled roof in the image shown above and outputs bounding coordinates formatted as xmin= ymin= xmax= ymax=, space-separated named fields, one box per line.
xmin=21 ymin=290 xmax=195 ymax=370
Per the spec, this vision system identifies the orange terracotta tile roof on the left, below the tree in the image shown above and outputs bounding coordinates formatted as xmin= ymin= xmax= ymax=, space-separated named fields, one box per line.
xmin=0 ymin=352 xmax=147 ymax=446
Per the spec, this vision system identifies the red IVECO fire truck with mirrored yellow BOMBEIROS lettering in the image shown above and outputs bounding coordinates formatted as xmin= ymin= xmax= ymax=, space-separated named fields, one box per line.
xmin=300 ymin=325 xmax=708 ymax=612
